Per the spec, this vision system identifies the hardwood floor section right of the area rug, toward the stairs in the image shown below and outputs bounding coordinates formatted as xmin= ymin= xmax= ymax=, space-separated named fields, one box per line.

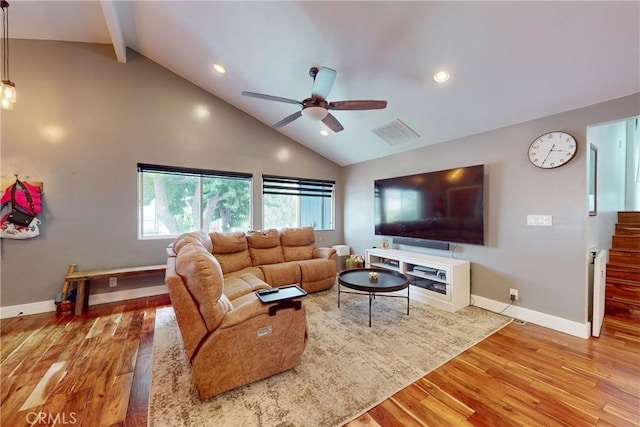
xmin=348 ymin=317 xmax=640 ymax=427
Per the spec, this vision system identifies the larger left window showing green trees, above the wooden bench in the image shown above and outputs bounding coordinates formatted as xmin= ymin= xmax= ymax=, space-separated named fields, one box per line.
xmin=138 ymin=163 xmax=253 ymax=238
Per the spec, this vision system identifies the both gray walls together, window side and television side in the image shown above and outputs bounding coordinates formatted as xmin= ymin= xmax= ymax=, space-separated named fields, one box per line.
xmin=0 ymin=40 xmax=640 ymax=328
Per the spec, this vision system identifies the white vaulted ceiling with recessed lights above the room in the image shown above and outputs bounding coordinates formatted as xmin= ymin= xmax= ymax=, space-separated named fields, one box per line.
xmin=9 ymin=0 xmax=640 ymax=165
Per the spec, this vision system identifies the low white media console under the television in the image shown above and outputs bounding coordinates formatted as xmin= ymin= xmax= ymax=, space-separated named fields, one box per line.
xmin=365 ymin=249 xmax=471 ymax=311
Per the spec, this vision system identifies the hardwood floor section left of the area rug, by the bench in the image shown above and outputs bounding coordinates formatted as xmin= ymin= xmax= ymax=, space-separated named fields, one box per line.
xmin=0 ymin=295 xmax=170 ymax=426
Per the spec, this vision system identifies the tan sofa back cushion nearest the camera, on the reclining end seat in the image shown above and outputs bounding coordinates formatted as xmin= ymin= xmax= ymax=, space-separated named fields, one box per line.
xmin=176 ymin=243 xmax=232 ymax=331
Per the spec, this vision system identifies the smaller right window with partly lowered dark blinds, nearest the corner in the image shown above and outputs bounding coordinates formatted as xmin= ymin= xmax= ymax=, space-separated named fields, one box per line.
xmin=262 ymin=175 xmax=335 ymax=230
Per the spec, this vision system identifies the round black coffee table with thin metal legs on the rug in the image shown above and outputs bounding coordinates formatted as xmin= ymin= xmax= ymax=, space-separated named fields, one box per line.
xmin=338 ymin=268 xmax=409 ymax=327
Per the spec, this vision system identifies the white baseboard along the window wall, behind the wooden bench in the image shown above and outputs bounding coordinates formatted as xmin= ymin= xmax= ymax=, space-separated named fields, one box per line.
xmin=0 ymin=285 xmax=169 ymax=319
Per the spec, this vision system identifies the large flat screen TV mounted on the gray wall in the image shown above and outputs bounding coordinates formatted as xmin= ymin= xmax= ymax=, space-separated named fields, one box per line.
xmin=374 ymin=165 xmax=484 ymax=245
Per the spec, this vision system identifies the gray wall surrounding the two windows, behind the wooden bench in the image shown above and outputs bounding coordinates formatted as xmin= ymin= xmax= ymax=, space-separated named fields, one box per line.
xmin=0 ymin=40 xmax=342 ymax=308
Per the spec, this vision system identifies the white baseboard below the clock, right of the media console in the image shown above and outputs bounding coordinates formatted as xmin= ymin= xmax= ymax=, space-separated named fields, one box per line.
xmin=471 ymin=295 xmax=591 ymax=339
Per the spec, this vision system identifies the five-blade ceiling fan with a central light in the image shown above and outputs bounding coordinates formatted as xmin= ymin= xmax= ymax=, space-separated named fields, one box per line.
xmin=242 ymin=67 xmax=387 ymax=132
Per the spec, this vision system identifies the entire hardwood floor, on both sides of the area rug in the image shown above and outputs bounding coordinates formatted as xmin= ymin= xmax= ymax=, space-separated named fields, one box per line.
xmin=0 ymin=296 xmax=640 ymax=427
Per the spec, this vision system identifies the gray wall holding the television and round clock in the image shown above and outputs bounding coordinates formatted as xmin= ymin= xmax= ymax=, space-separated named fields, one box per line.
xmin=342 ymin=94 xmax=640 ymax=323
